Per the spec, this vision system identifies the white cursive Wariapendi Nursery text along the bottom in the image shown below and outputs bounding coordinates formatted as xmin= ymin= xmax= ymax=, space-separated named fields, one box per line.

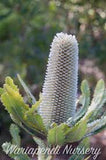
xmin=6 ymin=144 xmax=101 ymax=160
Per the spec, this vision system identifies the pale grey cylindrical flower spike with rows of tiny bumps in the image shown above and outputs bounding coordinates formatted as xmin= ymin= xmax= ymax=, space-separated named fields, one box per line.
xmin=39 ymin=33 xmax=78 ymax=125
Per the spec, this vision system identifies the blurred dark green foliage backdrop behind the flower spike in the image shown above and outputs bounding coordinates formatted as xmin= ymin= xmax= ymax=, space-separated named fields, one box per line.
xmin=0 ymin=0 xmax=106 ymax=160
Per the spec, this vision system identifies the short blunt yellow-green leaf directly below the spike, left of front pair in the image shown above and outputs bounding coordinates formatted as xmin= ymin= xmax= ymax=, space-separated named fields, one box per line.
xmin=48 ymin=124 xmax=65 ymax=145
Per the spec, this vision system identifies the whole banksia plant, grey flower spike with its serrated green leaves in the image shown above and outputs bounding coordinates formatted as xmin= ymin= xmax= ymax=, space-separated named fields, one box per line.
xmin=0 ymin=33 xmax=106 ymax=160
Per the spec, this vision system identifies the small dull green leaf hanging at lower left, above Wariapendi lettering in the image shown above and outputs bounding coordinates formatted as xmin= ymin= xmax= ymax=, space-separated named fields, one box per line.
xmin=10 ymin=124 xmax=21 ymax=147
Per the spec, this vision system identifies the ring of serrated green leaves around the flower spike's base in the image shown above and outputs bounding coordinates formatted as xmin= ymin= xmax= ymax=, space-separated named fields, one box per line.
xmin=0 ymin=75 xmax=106 ymax=160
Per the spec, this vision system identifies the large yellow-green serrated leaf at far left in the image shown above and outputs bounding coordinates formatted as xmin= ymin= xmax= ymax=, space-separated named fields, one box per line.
xmin=1 ymin=79 xmax=46 ymax=138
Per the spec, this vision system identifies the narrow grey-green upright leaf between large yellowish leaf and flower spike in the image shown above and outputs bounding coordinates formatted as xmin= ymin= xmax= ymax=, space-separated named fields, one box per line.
xmin=17 ymin=74 xmax=36 ymax=104
